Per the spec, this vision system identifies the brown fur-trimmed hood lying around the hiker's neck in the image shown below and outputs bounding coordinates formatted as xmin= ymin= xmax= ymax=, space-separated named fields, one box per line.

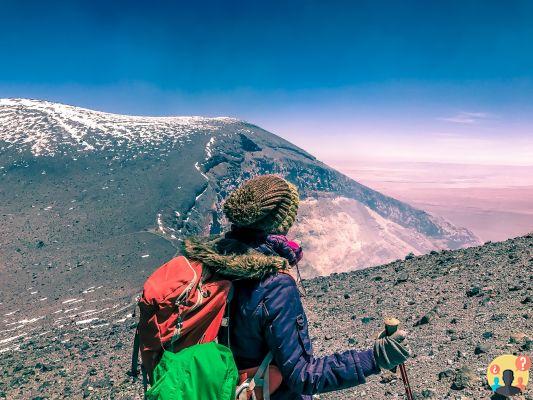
xmin=182 ymin=236 xmax=290 ymax=279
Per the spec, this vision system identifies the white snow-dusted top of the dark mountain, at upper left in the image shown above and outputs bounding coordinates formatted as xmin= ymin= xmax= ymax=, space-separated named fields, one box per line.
xmin=0 ymin=99 xmax=236 ymax=156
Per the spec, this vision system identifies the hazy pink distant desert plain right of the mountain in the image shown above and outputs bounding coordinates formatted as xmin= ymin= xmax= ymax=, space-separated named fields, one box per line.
xmin=329 ymin=162 xmax=533 ymax=241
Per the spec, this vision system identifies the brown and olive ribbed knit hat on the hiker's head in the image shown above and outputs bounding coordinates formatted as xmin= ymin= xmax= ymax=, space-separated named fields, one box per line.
xmin=224 ymin=175 xmax=299 ymax=233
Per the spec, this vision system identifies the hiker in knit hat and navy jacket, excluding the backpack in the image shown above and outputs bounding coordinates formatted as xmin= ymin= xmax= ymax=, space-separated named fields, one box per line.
xmin=184 ymin=175 xmax=409 ymax=400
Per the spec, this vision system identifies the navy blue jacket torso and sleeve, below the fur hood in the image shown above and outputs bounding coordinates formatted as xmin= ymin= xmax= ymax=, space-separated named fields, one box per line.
xmin=230 ymin=273 xmax=379 ymax=400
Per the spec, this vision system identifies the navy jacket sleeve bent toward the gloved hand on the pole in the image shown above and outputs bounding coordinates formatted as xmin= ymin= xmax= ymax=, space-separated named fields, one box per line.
xmin=263 ymin=274 xmax=379 ymax=395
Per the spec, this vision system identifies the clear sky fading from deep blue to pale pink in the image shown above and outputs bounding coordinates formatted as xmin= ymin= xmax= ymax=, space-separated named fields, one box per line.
xmin=0 ymin=0 xmax=533 ymax=164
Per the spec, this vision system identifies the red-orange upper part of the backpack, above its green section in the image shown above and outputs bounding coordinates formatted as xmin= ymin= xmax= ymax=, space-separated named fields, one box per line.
xmin=131 ymin=256 xmax=231 ymax=390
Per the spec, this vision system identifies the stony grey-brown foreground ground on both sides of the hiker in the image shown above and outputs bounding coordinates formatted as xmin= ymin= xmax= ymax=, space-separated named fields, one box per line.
xmin=0 ymin=235 xmax=533 ymax=400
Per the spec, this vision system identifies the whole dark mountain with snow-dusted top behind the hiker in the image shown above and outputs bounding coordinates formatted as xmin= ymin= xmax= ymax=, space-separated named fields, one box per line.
xmin=0 ymin=99 xmax=477 ymax=289
